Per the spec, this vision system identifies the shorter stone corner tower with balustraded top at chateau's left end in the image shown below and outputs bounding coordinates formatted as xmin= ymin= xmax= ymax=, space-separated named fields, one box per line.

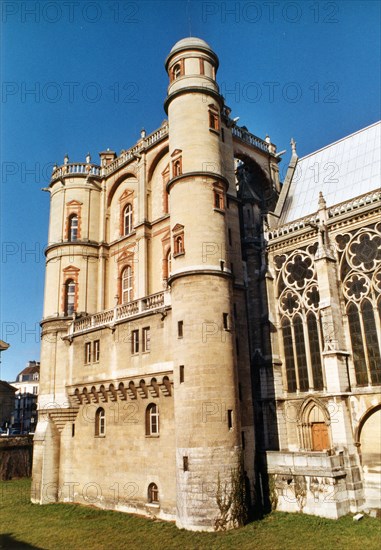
xmin=32 ymin=155 xmax=103 ymax=503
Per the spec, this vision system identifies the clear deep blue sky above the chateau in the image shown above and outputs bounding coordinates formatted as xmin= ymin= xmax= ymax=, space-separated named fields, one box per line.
xmin=0 ymin=0 xmax=381 ymax=381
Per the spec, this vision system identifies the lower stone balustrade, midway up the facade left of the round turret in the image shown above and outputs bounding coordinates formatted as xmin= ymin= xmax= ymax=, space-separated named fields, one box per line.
xmin=68 ymin=291 xmax=171 ymax=337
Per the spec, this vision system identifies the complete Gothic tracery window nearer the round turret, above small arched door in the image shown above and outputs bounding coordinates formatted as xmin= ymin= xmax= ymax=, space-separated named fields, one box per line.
xmin=275 ymin=245 xmax=324 ymax=392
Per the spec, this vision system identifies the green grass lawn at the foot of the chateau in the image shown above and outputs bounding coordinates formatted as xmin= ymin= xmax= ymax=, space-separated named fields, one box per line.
xmin=0 ymin=479 xmax=381 ymax=550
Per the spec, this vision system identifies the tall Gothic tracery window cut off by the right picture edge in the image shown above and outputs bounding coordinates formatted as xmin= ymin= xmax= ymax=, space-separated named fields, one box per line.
xmin=336 ymin=223 xmax=381 ymax=386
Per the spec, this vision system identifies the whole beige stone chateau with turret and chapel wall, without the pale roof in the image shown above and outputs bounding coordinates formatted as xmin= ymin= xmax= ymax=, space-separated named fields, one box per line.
xmin=32 ymin=38 xmax=381 ymax=530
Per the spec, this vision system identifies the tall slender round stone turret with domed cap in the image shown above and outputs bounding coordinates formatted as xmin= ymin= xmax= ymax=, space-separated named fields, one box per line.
xmin=165 ymin=38 xmax=240 ymax=530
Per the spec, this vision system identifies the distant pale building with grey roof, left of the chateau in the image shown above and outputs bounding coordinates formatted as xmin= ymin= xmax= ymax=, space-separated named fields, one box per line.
xmin=12 ymin=361 xmax=40 ymax=433
